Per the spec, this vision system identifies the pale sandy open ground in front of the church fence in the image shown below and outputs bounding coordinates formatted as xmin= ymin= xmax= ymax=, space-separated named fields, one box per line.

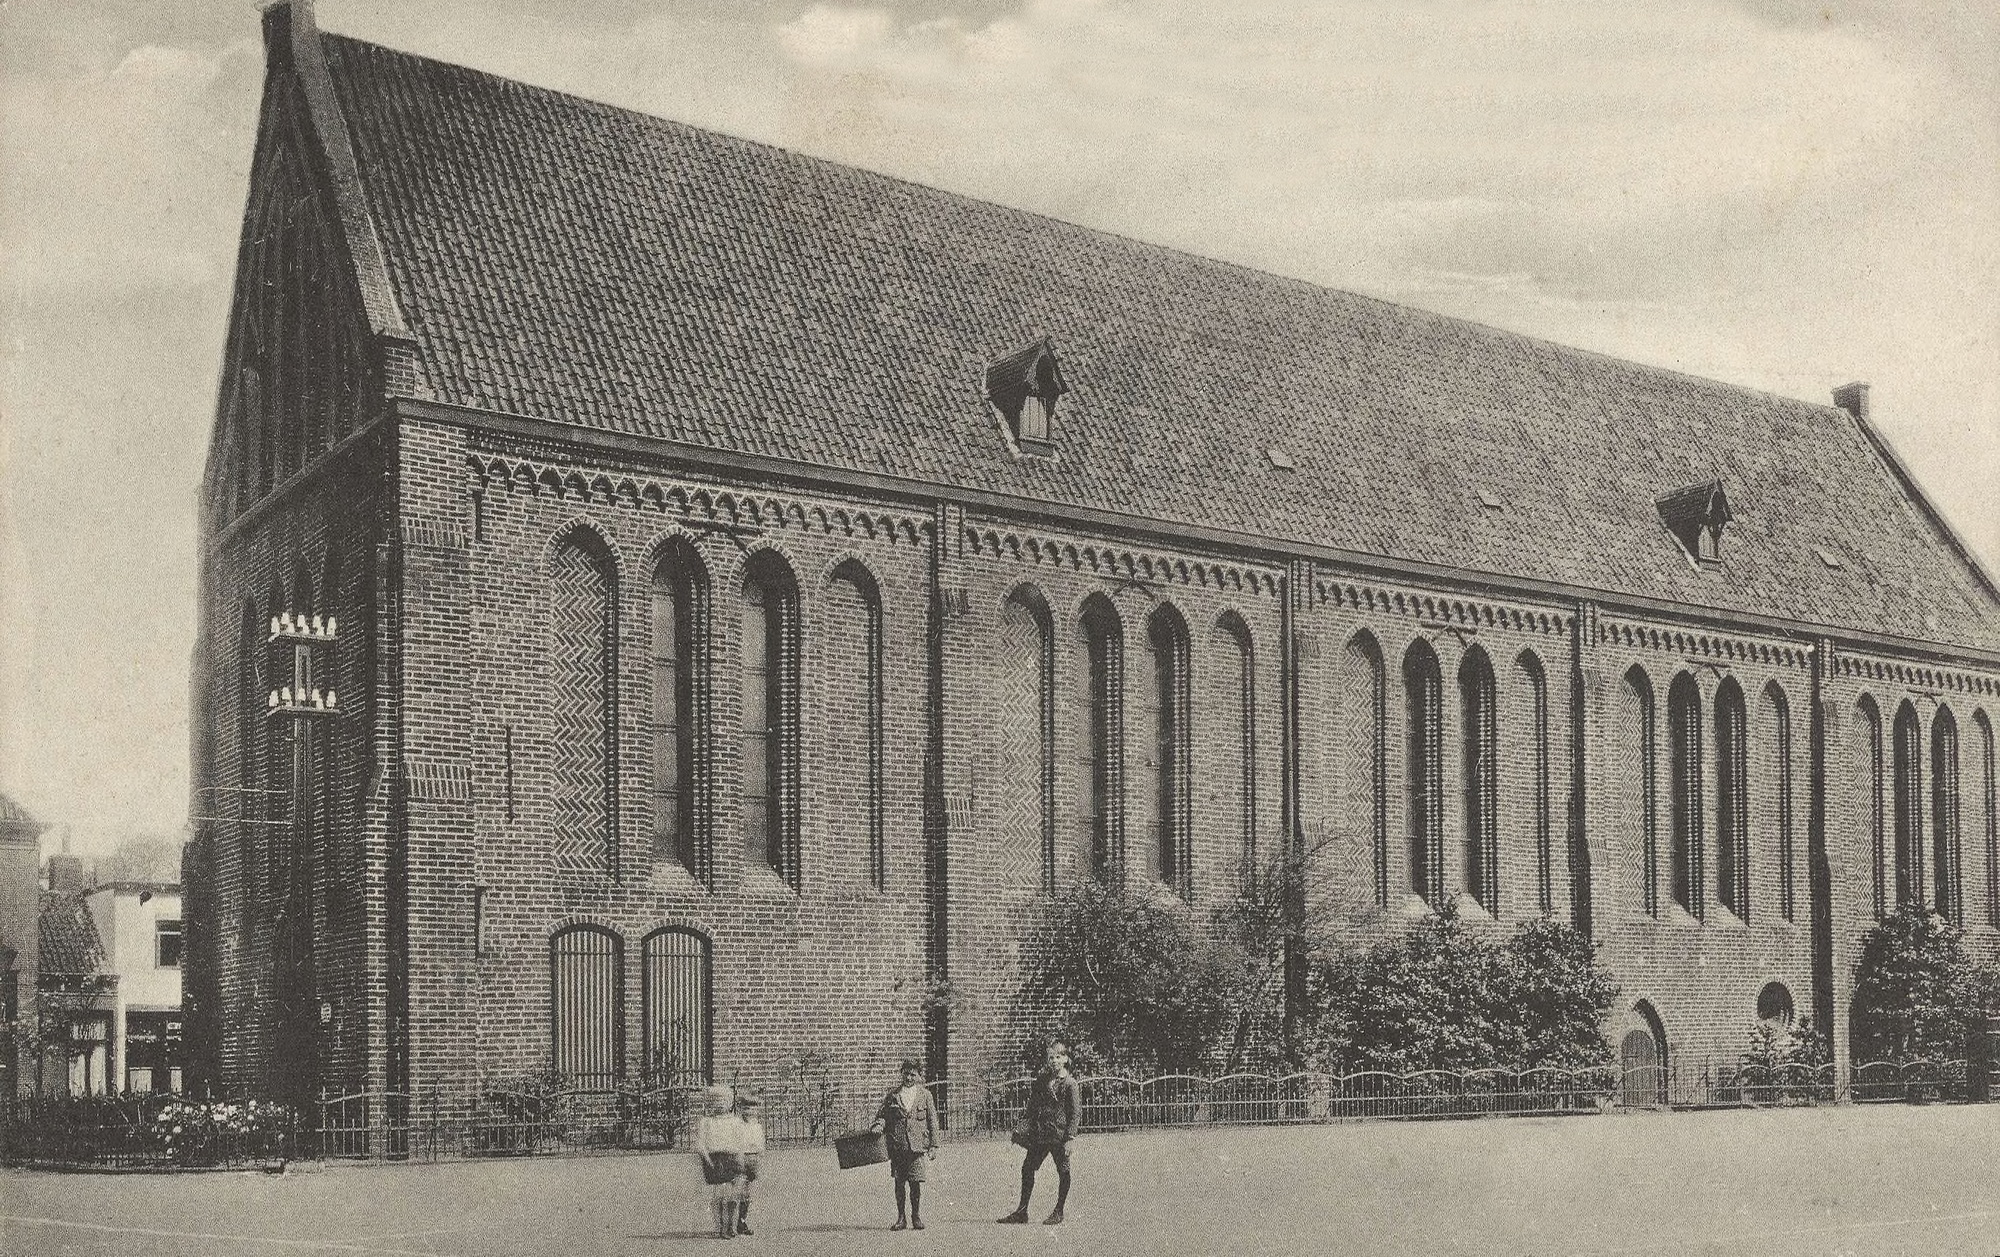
xmin=0 ymin=1105 xmax=2000 ymax=1257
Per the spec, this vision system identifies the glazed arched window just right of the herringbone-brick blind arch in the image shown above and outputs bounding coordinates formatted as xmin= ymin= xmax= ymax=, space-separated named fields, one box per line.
xmin=652 ymin=542 xmax=714 ymax=887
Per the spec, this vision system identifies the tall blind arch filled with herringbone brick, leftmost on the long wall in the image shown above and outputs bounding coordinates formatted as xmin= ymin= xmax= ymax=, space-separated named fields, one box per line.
xmin=550 ymin=528 xmax=618 ymax=877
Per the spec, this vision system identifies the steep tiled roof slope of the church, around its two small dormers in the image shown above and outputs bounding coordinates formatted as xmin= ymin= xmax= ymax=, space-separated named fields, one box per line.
xmin=324 ymin=36 xmax=2000 ymax=649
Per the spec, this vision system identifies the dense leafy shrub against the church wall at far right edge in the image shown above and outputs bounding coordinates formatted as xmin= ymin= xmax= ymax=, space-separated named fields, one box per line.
xmin=1852 ymin=907 xmax=2000 ymax=1063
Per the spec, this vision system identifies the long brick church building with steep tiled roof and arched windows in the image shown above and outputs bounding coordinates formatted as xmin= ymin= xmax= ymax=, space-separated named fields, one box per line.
xmin=186 ymin=0 xmax=2000 ymax=1095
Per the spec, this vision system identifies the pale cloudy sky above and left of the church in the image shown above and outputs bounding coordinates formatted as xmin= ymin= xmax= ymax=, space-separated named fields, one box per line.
xmin=0 ymin=0 xmax=2000 ymax=853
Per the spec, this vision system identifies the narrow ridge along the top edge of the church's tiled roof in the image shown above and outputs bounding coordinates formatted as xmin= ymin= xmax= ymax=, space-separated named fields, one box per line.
xmin=320 ymin=30 xmax=1846 ymax=416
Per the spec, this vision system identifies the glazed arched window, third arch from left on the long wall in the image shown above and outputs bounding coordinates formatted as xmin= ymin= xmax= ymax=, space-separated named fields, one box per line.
xmin=740 ymin=550 xmax=800 ymax=891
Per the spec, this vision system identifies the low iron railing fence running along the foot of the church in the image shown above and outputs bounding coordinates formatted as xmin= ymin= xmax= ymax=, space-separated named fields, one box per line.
xmin=0 ymin=1061 xmax=1968 ymax=1169
